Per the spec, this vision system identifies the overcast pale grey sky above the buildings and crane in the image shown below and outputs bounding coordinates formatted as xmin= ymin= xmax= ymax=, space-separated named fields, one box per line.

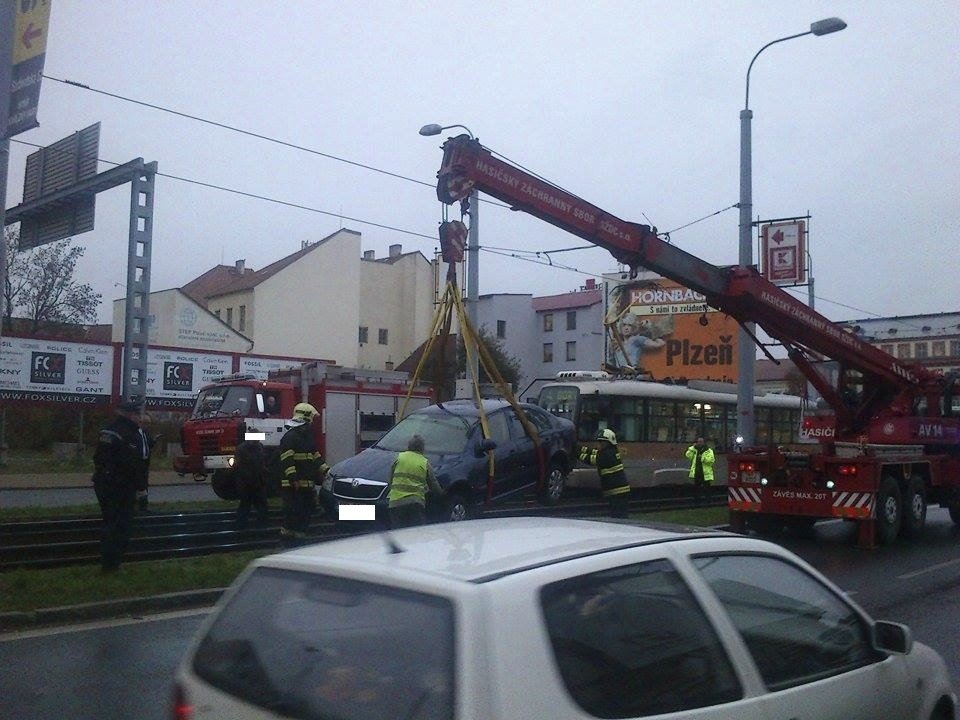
xmin=7 ymin=0 xmax=960 ymax=322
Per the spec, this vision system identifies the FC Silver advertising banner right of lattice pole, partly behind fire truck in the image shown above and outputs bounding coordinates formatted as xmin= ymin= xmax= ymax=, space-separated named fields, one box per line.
xmin=139 ymin=347 xmax=233 ymax=408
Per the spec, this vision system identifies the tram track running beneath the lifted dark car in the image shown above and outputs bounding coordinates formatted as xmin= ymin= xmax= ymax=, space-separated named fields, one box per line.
xmin=0 ymin=486 xmax=726 ymax=572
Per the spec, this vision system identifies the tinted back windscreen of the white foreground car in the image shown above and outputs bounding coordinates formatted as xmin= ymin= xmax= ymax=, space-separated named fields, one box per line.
xmin=192 ymin=568 xmax=454 ymax=720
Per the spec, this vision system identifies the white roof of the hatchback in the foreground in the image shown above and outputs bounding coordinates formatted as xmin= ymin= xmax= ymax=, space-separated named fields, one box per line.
xmin=256 ymin=517 xmax=736 ymax=583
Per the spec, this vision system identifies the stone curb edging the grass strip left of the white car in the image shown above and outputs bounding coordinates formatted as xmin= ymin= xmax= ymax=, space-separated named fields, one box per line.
xmin=0 ymin=588 xmax=226 ymax=633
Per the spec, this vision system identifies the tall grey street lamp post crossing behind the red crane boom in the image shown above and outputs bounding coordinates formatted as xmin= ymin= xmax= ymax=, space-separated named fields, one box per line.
xmin=737 ymin=18 xmax=847 ymax=446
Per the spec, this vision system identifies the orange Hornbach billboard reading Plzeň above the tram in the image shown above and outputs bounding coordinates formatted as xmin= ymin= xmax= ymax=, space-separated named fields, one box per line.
xmin=604 ymin=277 xmax=739 ymax=382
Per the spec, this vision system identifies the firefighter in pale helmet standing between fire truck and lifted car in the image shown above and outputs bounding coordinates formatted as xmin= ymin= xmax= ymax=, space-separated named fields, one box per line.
xmin=280 ymin=403 xmax=329 ymax=545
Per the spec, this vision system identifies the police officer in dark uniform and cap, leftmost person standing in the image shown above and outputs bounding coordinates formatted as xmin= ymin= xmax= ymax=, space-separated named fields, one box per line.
xmin=93 ymin=399 xmax=150 ymax=573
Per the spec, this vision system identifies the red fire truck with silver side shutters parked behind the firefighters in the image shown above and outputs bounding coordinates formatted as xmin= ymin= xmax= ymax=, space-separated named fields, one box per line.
xmin=173 ymin=362 xmax=432 ymax=500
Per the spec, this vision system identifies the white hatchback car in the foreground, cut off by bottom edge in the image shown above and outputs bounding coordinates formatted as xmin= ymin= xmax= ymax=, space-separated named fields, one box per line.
xmin=173 ymin=518 xmax=957 ymax=720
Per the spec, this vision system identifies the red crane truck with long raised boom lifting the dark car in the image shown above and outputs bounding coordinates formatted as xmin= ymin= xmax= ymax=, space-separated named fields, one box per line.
xmin=437 ymin=135 xmax=960 ymax=546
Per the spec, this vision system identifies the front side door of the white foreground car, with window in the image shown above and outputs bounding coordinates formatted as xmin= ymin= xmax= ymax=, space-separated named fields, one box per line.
xmin=693 ymin=553 xmax=919 ymax=720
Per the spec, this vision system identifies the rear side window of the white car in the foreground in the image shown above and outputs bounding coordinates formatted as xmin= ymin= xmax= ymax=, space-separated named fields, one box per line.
xmin=541 ymin=560 xmax=743 ymax=718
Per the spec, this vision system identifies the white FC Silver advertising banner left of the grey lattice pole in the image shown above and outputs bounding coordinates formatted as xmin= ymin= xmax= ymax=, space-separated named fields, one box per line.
xmin=0 ymin=337 xmax=113 ymax=405
